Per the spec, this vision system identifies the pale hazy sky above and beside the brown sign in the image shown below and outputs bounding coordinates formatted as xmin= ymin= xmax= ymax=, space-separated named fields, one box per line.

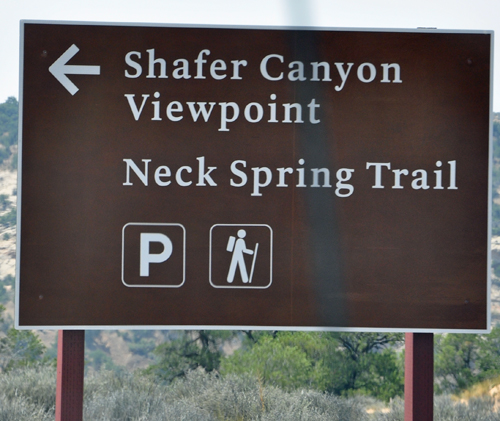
xmin=0 ymin=0 xmax=500 ymax=112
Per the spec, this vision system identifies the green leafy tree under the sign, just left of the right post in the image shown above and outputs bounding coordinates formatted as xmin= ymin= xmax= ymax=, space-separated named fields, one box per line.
xmin=220 ymin=332 xmax=404 ymax=400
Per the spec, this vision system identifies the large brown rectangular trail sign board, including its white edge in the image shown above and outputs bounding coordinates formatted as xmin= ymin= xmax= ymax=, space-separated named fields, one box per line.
xmin=16 ymin=21 xmax=493 ymax=332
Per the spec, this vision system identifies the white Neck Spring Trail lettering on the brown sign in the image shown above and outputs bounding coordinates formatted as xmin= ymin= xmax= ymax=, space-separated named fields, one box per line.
xmin=123 ymin=156 xmax=458 ymax=197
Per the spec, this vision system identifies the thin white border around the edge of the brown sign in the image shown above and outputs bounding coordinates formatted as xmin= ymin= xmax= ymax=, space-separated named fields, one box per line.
xmin=14 ymin=19 xmax=494 ymax=334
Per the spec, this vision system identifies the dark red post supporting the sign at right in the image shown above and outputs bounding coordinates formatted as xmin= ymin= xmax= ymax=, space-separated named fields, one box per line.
xmin=405 ymin=333 xmax=434 ymax=421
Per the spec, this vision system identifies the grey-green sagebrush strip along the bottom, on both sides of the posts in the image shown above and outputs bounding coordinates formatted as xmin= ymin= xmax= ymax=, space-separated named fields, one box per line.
xmin=0 ymin=366 xmax=500 ymax=421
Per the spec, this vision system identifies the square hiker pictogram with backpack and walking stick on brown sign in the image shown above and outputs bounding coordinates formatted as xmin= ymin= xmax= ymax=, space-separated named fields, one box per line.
xmin=209 ymin=224 xmax=273 ymax=289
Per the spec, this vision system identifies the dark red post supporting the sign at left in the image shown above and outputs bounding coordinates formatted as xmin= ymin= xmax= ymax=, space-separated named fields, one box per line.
xmin=56 ymin=330 xmax=85 ymax=421
